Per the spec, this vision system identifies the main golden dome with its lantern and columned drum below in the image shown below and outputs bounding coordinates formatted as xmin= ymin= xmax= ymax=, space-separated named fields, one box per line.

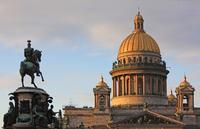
xmin=110 ymin=12 xmax=169 ymax=106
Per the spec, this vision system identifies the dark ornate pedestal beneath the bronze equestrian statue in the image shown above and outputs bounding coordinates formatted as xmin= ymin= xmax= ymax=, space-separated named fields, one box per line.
xmin=3 ymin=87 xmax=53 ymax=129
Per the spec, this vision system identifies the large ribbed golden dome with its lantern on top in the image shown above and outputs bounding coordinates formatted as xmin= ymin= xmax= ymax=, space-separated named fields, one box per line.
xmin=118 ymin=12 xmax=160 ymax=58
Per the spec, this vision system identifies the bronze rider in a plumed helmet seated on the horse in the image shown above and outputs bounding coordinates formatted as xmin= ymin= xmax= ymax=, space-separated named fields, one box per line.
xmin=24 ymin=40 xmax=40 ymax=76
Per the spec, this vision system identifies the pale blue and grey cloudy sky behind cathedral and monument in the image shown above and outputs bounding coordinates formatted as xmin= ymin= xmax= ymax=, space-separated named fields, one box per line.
xmin=0 ymin=0 xmax=200 ymax=126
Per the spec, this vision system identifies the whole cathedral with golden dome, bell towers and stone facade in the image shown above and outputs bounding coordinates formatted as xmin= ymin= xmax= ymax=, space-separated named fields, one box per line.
xmin=63 ymin=12 xmax=200 ymax=129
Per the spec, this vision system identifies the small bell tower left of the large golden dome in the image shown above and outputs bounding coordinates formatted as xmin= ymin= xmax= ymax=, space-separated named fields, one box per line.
xmin=93 ymin=76 xmax=111 ymax=113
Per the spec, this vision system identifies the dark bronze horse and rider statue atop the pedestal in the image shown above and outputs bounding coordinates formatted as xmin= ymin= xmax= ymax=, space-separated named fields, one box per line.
xmin=20 ymin=40 xmax=44 ymax=88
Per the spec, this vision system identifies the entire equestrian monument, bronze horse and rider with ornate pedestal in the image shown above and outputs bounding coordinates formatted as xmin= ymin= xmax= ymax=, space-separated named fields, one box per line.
xmin=3 ymin=40 xmax=61 ymax=129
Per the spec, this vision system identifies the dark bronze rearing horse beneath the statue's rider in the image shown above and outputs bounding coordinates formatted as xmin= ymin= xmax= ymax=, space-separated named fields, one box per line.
xmin=19 ymin=50 xmax=44 ymax=88
